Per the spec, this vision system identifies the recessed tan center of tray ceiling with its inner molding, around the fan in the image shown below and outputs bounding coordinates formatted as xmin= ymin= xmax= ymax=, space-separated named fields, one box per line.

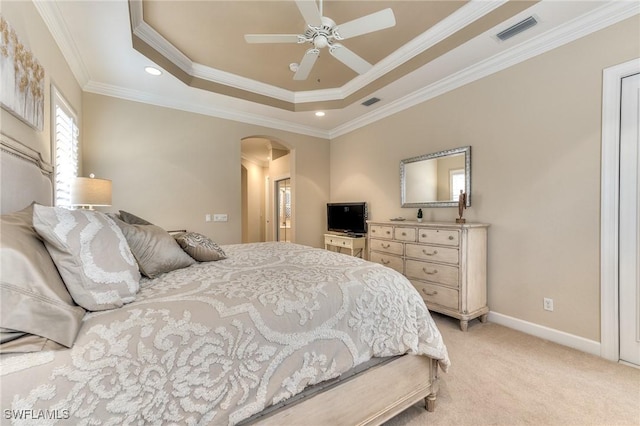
xmin=130 ymin=0 xmax=537 ymax=111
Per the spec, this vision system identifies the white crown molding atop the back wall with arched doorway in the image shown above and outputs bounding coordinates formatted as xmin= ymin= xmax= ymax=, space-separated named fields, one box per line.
xmin=83 ymin=81 xmax=329 ymax=139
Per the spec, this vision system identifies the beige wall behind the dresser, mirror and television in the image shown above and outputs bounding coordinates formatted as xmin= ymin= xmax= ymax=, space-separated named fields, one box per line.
xmin=330 ymin=17 xmax=640 ymax=341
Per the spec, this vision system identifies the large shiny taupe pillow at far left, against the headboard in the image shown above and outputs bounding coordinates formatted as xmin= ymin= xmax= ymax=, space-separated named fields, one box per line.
xmin=0 ymin=205 xmax=85 ymax=353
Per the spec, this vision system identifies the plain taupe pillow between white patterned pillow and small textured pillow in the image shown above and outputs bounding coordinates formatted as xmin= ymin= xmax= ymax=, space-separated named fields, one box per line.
xmin=115 ymin=220 xmax=195 ymax=278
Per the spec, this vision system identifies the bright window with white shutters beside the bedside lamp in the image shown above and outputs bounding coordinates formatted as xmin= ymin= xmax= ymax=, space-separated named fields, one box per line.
xmin=51 ymin=86 xmax=79 ymax=206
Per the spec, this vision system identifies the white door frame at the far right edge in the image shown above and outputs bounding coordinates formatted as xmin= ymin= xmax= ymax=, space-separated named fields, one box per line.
xmin=600 ymin=58 xmax=640 ymax=362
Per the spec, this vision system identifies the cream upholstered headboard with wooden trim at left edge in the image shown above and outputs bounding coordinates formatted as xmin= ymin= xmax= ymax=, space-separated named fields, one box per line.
xmin=0 ymin=134 xmax=53 ymax=214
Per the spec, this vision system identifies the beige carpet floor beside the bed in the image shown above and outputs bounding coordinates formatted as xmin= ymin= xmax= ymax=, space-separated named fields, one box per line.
xmin=385 ymin=313 xmax=640 ymax=426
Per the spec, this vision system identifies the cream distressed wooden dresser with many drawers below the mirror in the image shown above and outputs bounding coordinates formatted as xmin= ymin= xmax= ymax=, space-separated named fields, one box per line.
xmin=367 ymin=221 xmax=489 ymax=331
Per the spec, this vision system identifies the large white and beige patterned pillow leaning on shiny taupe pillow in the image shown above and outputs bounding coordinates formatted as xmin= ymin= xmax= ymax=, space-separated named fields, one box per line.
xmin=33 ymin=205 xmax=140 ymax=311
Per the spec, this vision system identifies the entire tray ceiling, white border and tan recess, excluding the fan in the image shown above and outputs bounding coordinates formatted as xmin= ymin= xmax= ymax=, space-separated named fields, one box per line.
xmin=33 ymin=0 xmax=640 ymax=139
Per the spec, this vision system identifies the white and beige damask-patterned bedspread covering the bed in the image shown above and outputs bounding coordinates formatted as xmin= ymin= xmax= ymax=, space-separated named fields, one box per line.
xmin=0 ymin=243 xmax=449 ymax=425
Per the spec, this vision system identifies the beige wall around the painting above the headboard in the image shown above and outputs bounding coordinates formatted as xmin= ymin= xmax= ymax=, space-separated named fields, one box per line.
xmin=0 ymin=1 xmax=82 ymax=170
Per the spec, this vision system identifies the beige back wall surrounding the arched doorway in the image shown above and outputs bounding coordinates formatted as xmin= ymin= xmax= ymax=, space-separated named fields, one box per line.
xmin=83 ymin=93 xmax=329 ymax=247
